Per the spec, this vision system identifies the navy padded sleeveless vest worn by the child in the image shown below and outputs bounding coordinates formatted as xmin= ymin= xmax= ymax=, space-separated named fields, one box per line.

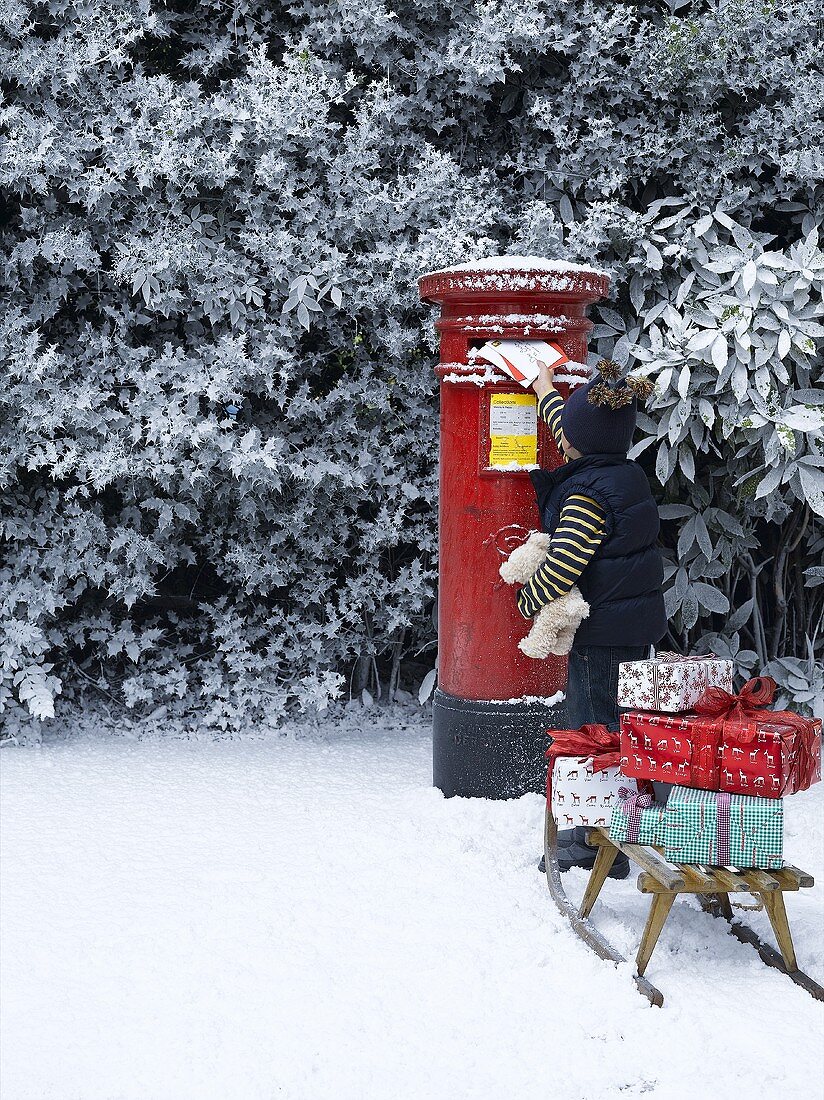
xmin=530 ymin=454 xmax=667 ymax=646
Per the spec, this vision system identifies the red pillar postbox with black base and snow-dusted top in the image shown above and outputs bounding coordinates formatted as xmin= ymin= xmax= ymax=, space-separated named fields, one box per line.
xmin=418 ymin=256 xmax=608 ymax=798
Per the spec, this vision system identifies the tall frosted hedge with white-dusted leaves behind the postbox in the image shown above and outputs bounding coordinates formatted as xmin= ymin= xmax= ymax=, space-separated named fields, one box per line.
xmin=0 ymin=0 xmax=824 ymax=728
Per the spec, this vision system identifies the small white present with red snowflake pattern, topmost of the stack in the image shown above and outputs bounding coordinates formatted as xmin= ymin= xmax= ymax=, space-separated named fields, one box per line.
xmin=618 ymin=653 xmax=733 ymax=714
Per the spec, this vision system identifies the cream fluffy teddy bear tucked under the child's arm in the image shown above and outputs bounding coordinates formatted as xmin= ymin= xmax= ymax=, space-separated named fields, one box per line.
xmin=499 ymin=531 xmax=590 ymax=660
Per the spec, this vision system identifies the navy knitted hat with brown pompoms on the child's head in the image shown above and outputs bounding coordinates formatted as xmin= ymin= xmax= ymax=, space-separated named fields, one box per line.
xmin=561 ymin=359 xmax=653 ymax=454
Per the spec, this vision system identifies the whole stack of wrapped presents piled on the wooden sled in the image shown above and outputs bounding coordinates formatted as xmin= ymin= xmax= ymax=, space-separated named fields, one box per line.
xmin=547 ymin=653 xmax=822 ymax=870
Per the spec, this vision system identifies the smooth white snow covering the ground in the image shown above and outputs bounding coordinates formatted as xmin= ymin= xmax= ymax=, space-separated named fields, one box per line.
xmin=0 ymin=710 xmax=824 ymax=1100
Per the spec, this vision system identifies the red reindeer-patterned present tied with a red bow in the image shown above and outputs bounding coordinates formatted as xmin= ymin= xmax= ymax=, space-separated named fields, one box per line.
xmin=620 ymin=677 xmax=821 ymax=799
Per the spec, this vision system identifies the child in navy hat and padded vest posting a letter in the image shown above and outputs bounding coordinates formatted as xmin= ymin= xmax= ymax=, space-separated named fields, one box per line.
xmin=517 ymin=360 xmax=667 ymax=878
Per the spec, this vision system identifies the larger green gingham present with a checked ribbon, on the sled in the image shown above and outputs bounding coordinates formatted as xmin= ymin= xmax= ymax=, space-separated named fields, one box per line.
xmin=664 ymin=787 xmax=784 ymax=871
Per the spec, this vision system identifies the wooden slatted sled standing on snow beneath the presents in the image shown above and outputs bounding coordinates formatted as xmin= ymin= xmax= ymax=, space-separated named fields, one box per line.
xmin=543 ymin=807 xmax=824 ymax=1007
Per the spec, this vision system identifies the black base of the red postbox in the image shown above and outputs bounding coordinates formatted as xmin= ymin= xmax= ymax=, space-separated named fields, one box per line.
xmin=432 ymin=690 xmax=564 ymax=799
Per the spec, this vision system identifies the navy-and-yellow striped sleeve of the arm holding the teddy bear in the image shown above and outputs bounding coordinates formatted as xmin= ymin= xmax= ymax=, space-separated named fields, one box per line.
xmin=517 ymin=493 xmax=606 ymax=618
